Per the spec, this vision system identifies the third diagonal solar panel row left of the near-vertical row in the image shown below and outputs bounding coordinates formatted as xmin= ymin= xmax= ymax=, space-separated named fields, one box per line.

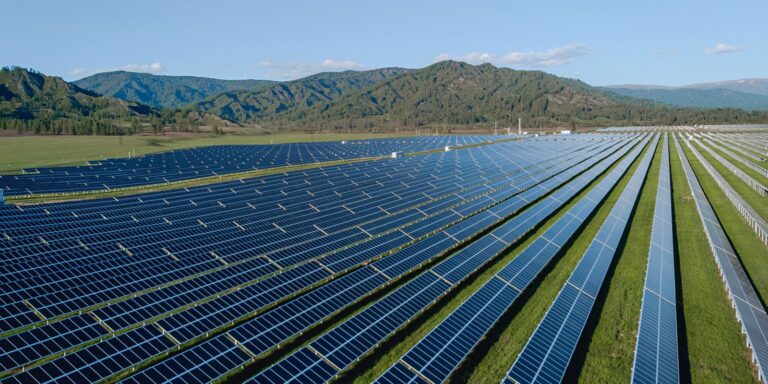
xmin=251 ymin=135 xmax=644 ymax=383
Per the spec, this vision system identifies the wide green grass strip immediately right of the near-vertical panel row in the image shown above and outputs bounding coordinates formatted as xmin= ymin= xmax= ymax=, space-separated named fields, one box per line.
xmin=669 ymin=137 xmax=756 ymax=383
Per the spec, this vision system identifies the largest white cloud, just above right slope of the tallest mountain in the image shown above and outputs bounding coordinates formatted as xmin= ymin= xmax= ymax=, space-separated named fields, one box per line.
xmin=435 ymin=44 xmax=591 ymax=68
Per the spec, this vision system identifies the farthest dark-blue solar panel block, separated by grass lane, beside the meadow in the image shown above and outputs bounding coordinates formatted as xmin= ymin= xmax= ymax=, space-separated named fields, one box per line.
xmin=0 ymin=135 xmax=521 ymax=196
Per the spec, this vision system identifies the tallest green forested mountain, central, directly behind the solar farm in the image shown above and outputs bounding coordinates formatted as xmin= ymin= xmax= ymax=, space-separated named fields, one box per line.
xmin=270 ymin=61 xmax=618 ymax=126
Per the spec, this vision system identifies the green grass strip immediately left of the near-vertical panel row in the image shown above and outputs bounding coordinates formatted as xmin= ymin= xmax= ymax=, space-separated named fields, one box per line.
xmin=573 ymin=135 xmax=664 ymax=383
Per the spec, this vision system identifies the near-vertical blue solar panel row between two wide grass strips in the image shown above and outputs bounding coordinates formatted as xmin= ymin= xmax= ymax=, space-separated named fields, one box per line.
xmin=632 ymin=134 xmax=680 ymax=384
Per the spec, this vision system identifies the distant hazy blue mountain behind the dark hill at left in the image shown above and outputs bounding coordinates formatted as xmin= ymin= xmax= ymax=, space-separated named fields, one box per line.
xmin=74 ymin=71 xmax=275 ymax=108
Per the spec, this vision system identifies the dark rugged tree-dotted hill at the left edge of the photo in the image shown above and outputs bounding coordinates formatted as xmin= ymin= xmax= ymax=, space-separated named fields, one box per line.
xmin=0 ymin=67 xmax=153 ymax=120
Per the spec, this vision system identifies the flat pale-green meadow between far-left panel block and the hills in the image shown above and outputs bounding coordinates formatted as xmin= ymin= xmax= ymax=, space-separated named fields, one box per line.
xmin=0 ymin=133 xmax=414 ymax=173
